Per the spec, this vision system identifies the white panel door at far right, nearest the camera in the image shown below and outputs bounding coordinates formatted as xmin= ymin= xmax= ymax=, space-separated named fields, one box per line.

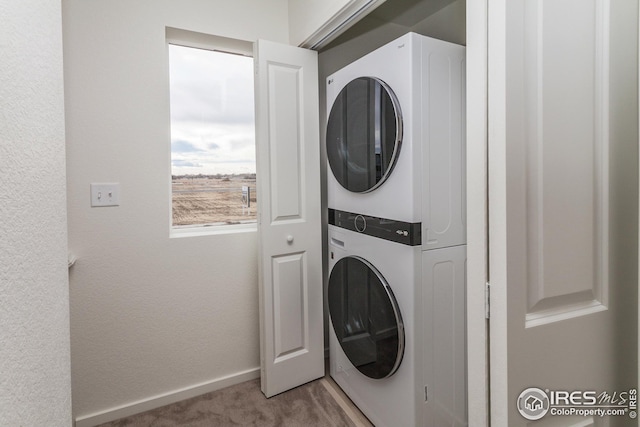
xmin=488 ymin=0 xmax=637 ymax=426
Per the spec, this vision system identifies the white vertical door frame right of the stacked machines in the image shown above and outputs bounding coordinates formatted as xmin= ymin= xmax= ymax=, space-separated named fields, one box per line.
xmin=466 ymin=0 xmax=490 ymax=427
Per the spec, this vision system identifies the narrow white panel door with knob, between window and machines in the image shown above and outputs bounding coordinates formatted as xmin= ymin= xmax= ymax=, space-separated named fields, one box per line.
xmin=254 ymin=40 xmax=324 ymax=397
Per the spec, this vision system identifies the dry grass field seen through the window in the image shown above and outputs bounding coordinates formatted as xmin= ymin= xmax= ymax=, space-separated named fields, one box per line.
xmin=172 ymin=176 xmax=257 ymax=226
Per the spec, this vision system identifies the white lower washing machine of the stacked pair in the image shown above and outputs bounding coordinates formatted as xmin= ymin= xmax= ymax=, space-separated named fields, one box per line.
xmin=327 ymin=226 xmax=467 ymax=427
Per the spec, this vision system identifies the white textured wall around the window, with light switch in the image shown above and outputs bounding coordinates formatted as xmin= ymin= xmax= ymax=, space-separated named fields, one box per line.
xmin=62 ymin=0 xmax=289 ymax=424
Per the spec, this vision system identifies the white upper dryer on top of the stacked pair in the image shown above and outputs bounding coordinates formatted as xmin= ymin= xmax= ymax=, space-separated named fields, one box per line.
xmin=326 ymin=33 xmax=465 ymax=249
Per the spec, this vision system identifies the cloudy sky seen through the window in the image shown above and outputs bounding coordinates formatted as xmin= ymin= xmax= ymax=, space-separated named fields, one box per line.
xmin=169 ymin=45 xmax=256 ymax=175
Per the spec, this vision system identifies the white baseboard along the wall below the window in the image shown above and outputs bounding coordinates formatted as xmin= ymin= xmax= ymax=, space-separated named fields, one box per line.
xmin=75 ymin=368 xmax=260 ymax=427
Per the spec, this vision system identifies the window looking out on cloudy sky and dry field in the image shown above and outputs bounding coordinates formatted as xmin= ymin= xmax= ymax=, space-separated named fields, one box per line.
xmin=168 ymin=30 xmax=257 ymax=230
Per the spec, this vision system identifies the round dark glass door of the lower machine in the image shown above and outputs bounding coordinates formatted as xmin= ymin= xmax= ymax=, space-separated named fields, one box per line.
xmin=329 ymin=256 xmax=404 ymax=379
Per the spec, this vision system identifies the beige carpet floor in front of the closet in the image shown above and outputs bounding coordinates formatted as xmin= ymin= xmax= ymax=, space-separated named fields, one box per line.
xmin=99 ymin=379 xmax=361 ymax=427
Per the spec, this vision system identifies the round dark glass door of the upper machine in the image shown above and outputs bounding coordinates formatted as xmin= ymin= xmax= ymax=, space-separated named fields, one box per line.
xmin=326 ymin=77 xmax=402 ymax=193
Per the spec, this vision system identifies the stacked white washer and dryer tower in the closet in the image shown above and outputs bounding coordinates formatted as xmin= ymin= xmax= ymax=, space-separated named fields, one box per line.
xmin=326 ymin=33 xmax=467 ymax=427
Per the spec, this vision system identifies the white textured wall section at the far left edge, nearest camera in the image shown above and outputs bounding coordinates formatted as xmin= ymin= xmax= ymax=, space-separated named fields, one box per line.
xmin=0 ymin=0 xmax=71 ymax=426
